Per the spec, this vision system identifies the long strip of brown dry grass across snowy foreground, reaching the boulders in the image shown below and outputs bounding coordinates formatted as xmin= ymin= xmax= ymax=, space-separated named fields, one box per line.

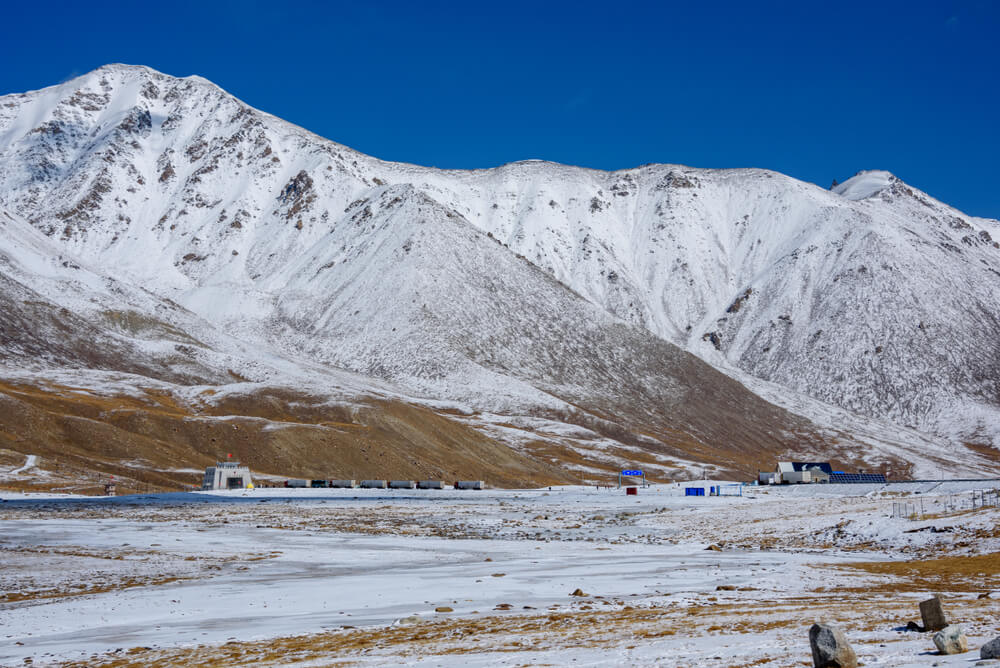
xmin=65 ymin=592 xmax=1000 ymax=668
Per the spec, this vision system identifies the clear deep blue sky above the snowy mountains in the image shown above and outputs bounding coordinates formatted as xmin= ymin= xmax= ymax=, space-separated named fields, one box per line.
xmin=0 ymin=0 xmax=1000 ymax=218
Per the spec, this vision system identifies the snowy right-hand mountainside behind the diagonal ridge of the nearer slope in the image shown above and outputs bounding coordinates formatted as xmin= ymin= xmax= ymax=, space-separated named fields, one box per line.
xmin=392 ymin=163 xmax=1000 ymax=445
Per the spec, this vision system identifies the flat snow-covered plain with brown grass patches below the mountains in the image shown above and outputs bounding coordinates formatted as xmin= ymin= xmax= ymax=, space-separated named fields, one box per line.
xmin=0 ymin=482 xmax=1000 ymax=666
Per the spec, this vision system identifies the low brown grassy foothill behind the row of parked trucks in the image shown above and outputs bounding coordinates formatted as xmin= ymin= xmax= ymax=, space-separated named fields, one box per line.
xmin=0 ymin=381 xmax=578 ymax=494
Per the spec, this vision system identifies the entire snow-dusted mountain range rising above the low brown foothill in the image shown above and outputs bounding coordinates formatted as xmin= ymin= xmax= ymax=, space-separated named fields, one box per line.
xmin=0 ymin=65 xmax=1000 ymax=486
